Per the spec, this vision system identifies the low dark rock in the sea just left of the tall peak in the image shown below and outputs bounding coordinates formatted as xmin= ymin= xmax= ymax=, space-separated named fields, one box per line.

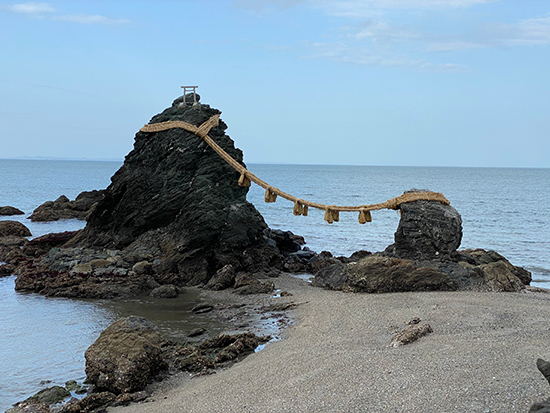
xmin=29 ymin=190 xmax=103 ymax=222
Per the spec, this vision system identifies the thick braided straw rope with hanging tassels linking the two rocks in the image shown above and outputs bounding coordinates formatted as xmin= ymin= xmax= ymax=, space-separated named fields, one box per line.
xmin=140 ymin=114 xmax=450 ymax=224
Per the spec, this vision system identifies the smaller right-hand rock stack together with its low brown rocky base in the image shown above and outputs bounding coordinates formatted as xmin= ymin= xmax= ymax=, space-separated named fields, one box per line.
xmin=310 ymin=191 xmax=531 ymax=293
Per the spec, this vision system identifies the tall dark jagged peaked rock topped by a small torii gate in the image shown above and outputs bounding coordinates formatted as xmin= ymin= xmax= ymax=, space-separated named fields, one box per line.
xmin=70 ymin=99 xmax=282 ymax=285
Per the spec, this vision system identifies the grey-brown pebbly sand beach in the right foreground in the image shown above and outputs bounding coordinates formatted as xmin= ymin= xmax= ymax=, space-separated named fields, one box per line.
xmin=108 ymin=276 xmax=550 ymax=413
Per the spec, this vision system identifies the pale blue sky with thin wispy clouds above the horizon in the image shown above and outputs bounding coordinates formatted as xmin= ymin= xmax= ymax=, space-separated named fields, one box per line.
xmin=0 ymin=0 xmax=550 ymax=167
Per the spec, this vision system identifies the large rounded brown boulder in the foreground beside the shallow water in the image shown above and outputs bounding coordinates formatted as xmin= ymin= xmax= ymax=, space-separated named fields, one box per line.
xmin=85 ymin=316 xmax=167 ymax=394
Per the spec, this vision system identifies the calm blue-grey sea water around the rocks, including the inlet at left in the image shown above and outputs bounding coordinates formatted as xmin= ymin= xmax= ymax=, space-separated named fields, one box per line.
xmin=0 ymin=160 xmax=550 ymax=411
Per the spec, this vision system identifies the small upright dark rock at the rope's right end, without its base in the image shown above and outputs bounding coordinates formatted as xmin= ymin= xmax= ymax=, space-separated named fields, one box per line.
xmin=385 ymin=189 xmax=462 ymax=260
